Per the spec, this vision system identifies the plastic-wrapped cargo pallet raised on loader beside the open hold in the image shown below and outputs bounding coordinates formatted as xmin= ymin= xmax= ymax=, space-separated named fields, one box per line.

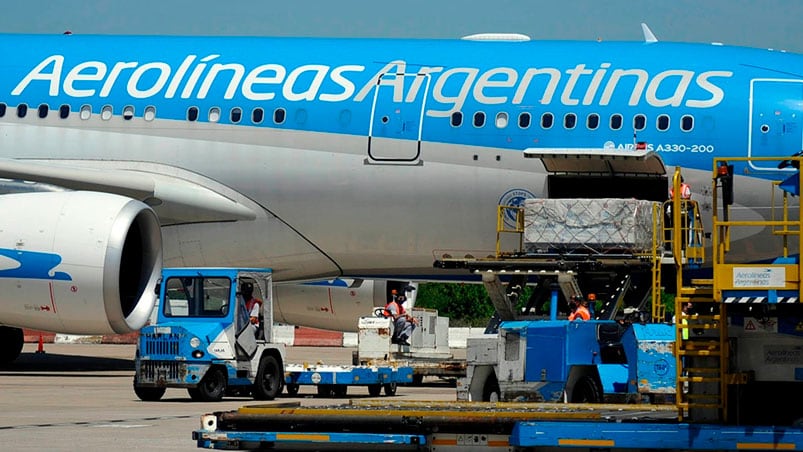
xmin=524 ymin=198 xmax=663 ymax=253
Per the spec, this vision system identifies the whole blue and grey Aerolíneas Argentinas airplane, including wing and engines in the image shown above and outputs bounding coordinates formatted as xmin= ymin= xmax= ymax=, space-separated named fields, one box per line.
xmin=0 ymin=30 xmax=803 ymax=362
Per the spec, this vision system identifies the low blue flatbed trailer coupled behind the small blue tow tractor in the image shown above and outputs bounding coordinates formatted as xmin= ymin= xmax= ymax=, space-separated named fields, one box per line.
xmin=284 ymin=364 xmax=413 ymax=397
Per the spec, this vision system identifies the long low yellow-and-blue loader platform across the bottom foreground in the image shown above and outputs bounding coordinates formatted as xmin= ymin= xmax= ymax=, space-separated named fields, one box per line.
xmin=193 ymin=400 xmax=803 ymax=451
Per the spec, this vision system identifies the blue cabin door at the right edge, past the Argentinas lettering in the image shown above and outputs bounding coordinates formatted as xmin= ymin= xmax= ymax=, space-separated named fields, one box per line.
xmin=747 ymin=79 xmax=803 ymax=171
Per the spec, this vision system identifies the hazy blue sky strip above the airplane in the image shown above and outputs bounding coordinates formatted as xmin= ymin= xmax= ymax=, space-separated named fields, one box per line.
xmin=0 ymin=0 xmax=803 ymax=53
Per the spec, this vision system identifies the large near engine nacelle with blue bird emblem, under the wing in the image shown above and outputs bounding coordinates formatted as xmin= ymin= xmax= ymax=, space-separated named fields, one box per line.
xmin=0 ymin=191 xmax=162 ymax=334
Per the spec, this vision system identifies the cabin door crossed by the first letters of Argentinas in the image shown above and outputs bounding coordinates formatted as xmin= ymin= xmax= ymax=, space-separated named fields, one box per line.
xmin=368 ymin=73 xmax=431 ymax=163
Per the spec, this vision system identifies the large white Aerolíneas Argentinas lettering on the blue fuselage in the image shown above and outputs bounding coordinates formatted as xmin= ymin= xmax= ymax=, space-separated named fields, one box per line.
xmin=11 ymin=54 xmax=733 ymax=117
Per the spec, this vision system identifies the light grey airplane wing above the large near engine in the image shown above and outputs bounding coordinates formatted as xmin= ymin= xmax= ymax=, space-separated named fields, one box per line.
xmin=0 ymin=159 xmax=256 ymax=226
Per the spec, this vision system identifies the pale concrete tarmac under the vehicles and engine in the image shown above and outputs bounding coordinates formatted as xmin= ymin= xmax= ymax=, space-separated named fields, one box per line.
xmin=0 ymin=344 xmax=465 ymax=451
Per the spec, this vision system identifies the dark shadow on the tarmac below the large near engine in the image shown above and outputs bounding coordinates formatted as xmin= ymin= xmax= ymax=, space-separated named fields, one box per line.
xmin=0 ymin=353 xmax=134 ymax=377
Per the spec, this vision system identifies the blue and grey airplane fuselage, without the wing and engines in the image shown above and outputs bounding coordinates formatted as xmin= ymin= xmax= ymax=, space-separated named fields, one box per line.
xmin=0 ymin=35 xmax=803 ymax=280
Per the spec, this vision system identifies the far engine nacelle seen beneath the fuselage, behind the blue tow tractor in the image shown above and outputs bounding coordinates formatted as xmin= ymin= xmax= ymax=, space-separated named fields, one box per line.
xmin=273 ymin=278 xmax=417 ymax=331
